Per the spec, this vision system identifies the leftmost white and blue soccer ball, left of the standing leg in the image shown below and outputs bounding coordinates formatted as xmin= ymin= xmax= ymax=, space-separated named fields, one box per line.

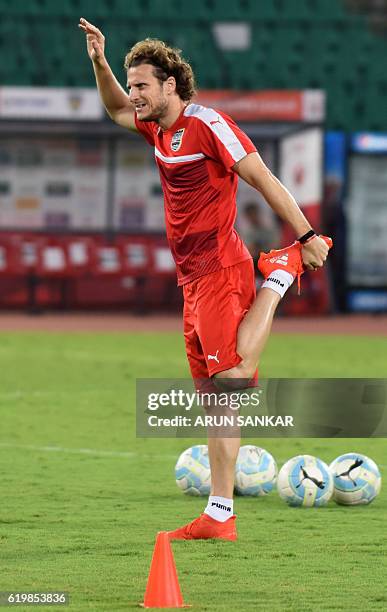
xmin=175 ymin=444 xmax=211 ymax=495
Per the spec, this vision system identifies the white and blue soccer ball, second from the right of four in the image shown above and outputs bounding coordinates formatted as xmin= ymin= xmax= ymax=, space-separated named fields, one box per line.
xmin=277 ymin=455 xmax=333 ymax=507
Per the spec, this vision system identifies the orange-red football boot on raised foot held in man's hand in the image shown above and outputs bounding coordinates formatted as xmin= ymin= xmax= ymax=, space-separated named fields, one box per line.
xmin=258 ymin=236 xmax=333 ymax=293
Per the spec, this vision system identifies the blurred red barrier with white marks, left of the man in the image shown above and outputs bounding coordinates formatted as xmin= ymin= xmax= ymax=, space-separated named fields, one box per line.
xmin=0 ymin=233 xmax=182 ymax=312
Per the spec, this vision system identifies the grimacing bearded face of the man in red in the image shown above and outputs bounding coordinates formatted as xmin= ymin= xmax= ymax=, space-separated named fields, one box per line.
xmin=127 ymin=64 xmax=168 ymax=121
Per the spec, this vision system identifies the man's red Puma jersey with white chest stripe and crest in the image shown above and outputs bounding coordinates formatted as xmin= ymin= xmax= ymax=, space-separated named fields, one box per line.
xmin=135 ymin=104 xmax=256 ymax=285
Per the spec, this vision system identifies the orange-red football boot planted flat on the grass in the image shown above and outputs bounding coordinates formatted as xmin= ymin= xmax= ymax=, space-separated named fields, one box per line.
xmin=168 ymin=512 xmax=237 ymax=542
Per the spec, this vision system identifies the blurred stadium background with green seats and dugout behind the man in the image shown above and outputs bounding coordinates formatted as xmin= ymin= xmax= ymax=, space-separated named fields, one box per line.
xmin=0 ymin=0 xmax=387 ymax=314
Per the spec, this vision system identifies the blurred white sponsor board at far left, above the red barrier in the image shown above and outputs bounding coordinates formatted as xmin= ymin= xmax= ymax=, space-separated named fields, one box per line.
xmin=0 ymin=138 xmax=108 ymax=230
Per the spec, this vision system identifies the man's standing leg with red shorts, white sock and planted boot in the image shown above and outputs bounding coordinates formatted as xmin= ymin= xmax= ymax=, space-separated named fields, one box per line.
xmin=170 ymin=270 xmax=247 ymax=541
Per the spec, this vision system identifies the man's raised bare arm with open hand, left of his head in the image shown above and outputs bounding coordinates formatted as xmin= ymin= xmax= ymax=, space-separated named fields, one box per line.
xmin=79 ymin=17 xmax=136 ymax=130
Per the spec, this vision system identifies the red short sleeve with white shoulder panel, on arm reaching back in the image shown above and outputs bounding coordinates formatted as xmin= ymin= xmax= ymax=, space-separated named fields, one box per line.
xmin=198 ymin=109 xmax=257 ymax=171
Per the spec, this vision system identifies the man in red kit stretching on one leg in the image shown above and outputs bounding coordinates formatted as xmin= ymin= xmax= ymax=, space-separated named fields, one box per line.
xmin=79 ymin=19 xmax=331 ymax=540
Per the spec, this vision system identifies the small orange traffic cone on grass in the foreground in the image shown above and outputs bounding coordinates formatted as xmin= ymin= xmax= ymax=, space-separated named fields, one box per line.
xmin=142 ymin=531 xmax=186 ymax=608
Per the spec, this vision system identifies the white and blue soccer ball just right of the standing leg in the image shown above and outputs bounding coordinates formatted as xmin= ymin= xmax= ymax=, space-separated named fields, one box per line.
xmin=235 ymin=444 xmax=278 ymax=497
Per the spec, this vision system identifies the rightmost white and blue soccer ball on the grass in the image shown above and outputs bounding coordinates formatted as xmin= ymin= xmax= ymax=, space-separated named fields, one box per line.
xmin=329 ymin=453 xmax=382 ymax=506
